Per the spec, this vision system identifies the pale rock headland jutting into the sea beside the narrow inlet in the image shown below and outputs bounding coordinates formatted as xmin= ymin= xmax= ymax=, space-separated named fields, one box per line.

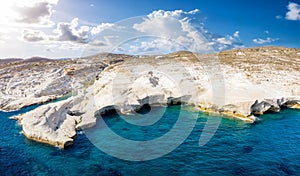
xmin=16 ymin=98 xmax=80 ymax=148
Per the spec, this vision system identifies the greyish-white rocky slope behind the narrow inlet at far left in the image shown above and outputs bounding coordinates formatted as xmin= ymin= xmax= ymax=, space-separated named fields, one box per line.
xmin=0 ymin=55 xmax=122 ymax=111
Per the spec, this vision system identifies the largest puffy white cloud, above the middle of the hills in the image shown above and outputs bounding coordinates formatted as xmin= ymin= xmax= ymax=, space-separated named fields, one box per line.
xmin=133 ymin=9 xmax=218 ymax=52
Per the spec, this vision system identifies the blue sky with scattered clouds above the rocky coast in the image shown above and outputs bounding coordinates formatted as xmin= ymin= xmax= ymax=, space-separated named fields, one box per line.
xmin=0 ymin=0 xmax=300 ymax=59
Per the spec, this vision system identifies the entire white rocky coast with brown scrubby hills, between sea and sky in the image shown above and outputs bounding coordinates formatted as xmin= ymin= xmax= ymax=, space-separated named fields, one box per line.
xmin=0 ymin=47 xmax=300 ymax=147
